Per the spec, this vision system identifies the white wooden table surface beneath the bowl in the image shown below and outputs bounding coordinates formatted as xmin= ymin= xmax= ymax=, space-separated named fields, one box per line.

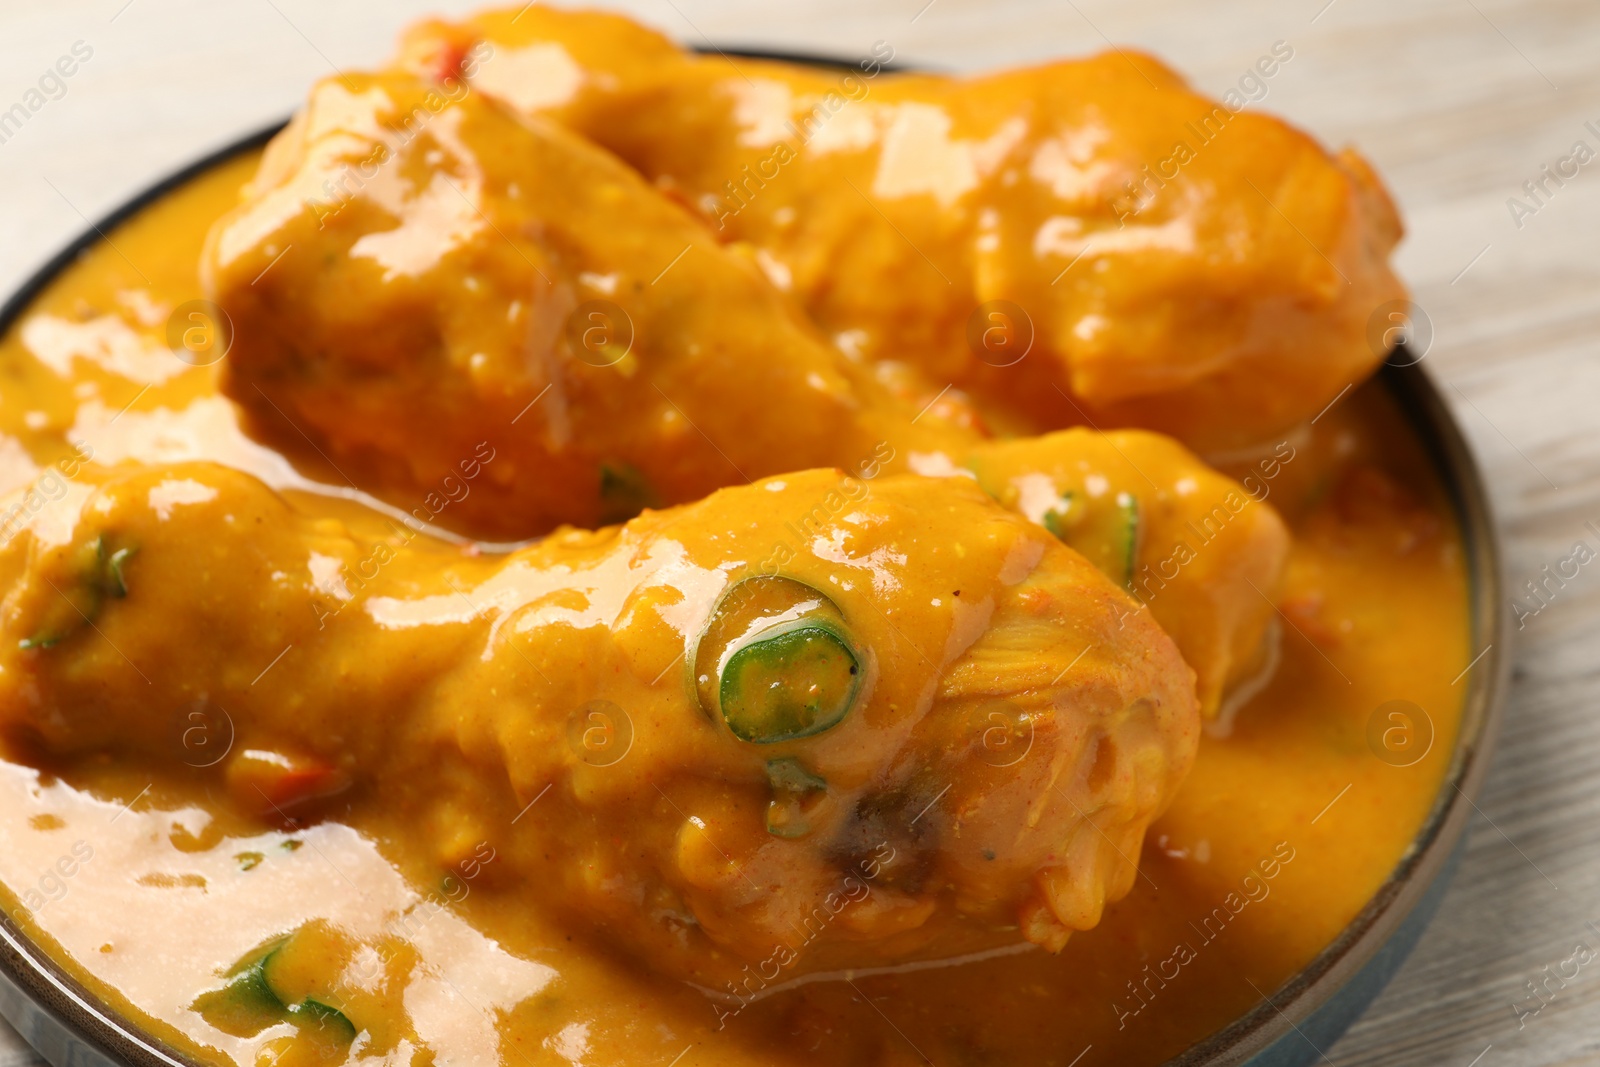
xmin=0 ymin=0 xmax=1600 ymax=1067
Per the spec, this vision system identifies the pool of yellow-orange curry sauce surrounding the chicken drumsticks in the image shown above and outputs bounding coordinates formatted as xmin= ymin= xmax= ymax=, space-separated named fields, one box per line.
xmin=0 ymin=154 xmax=1470 ymax=1067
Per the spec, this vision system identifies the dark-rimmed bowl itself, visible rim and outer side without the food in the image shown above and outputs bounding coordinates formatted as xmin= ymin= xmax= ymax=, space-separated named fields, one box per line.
xmin=0 ymin=48 xmax=1510 ymax=1067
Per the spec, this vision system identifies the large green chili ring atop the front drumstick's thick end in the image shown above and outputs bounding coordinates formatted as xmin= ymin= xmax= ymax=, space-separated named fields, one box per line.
xmin=694 ymin=576 xmax=862 ymax=744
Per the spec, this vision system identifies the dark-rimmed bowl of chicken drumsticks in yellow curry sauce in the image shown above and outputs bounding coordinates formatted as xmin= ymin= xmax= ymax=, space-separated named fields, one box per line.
xmin=0 ymin=6 xmax=1506 ymax=1067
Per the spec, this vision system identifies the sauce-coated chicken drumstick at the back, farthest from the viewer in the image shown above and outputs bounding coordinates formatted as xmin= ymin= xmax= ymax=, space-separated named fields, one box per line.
xmin=400 ymin=3 xmax=1405 ymax=448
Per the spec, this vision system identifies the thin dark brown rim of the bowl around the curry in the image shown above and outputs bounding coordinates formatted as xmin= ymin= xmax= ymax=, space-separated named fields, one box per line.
xmin=0 ymin=89 xmax=1510 ymax=1067
